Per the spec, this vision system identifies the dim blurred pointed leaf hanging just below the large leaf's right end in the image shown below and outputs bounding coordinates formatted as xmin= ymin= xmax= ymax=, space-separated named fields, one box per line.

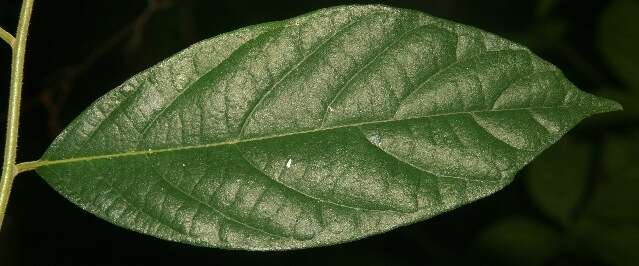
xmin=526 ymin=138 xmax=592 ymax=224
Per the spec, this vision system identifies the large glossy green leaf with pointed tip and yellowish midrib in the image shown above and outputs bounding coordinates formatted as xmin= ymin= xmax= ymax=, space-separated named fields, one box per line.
xmin=37 ymin=6 xmax=620 ymax=250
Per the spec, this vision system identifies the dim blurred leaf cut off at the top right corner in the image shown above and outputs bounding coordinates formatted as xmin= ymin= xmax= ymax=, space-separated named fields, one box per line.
xmin=598 ymin=0 xmax=639 ymax=88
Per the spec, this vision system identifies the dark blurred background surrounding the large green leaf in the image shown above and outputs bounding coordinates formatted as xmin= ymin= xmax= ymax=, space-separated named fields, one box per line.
xmin=0 ymin=0 xmax=639 ymax=266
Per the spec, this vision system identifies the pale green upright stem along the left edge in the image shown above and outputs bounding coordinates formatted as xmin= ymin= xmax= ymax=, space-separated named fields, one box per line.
xmin=0 ymin=0 xmax=34 ymax=231
